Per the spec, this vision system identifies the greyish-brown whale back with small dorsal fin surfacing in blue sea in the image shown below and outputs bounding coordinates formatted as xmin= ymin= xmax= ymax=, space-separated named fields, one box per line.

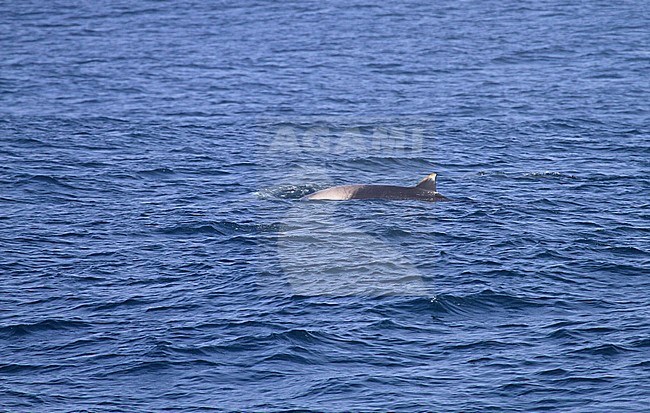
xmin=302 ymin=173 xmax=449 ymax=202
